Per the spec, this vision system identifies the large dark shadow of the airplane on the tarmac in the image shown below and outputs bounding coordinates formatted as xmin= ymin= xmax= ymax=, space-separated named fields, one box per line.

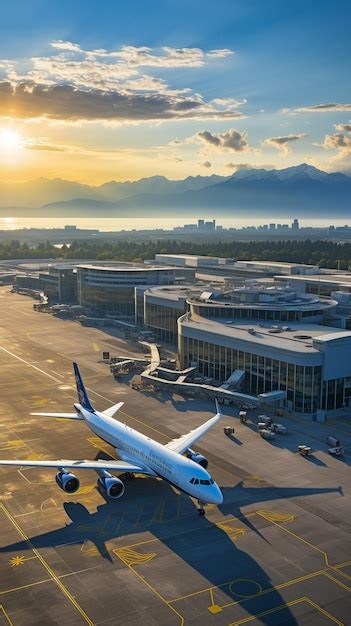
xmin=0 ymin=470 xmax=341 ymax=625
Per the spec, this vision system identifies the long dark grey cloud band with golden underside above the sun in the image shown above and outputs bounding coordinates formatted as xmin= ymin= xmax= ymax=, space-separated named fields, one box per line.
xmin=0 ymin=81 xmax=248 ymax=123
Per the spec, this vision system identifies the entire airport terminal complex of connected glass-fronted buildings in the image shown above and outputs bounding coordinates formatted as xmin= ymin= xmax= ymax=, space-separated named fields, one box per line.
xmin=11 ymin=255 xmax=351 ymax=414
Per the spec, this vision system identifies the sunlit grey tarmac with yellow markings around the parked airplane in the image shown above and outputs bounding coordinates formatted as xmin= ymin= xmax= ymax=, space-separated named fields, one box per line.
xmin=0 ymin=287 xmax=351 ymax=626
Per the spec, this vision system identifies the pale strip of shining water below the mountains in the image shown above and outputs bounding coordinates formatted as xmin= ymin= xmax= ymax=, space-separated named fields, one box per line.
xmin=0 ymin=216 xmax=351 ymax=232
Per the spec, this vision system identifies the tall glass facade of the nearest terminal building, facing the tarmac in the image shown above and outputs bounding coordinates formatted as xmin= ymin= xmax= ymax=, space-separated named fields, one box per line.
xmin=179 ymin=335 xmax=336 ymax=413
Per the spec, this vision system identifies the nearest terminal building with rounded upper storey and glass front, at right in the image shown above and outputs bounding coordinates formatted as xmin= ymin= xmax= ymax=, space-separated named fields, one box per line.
xmin=178 ymin=285 xmax=351 ymax=414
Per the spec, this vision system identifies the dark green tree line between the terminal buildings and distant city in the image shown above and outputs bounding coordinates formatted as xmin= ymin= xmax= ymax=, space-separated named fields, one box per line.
xmin=0 ymin=238 xmax=351 ymax=270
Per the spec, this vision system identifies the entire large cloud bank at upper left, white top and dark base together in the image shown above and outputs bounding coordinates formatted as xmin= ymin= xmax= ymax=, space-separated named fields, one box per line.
xmin=0 ymin=40 xmax=246 ymax=123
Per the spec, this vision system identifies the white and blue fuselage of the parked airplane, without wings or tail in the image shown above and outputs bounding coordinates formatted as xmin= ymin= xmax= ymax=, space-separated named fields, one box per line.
xmin=80 ymin=405 xmax=223 ymax=504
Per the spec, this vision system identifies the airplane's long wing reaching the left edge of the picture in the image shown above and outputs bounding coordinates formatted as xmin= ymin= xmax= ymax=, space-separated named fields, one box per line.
xmin=0 ymin=459 xmax=154 ymax=476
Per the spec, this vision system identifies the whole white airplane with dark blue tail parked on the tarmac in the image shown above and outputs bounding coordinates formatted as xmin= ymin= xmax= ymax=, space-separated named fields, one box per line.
xmin=0 ymin=363 xmax=223 ymax=515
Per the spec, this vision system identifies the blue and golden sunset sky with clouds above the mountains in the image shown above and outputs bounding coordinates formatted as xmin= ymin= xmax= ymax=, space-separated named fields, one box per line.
xmin=0 ymin=0 xmax=351 ymax=182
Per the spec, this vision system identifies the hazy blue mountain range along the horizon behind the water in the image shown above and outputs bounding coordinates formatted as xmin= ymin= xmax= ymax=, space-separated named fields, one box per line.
xmin=0 ymin=163 xmax=351 ymax=217
